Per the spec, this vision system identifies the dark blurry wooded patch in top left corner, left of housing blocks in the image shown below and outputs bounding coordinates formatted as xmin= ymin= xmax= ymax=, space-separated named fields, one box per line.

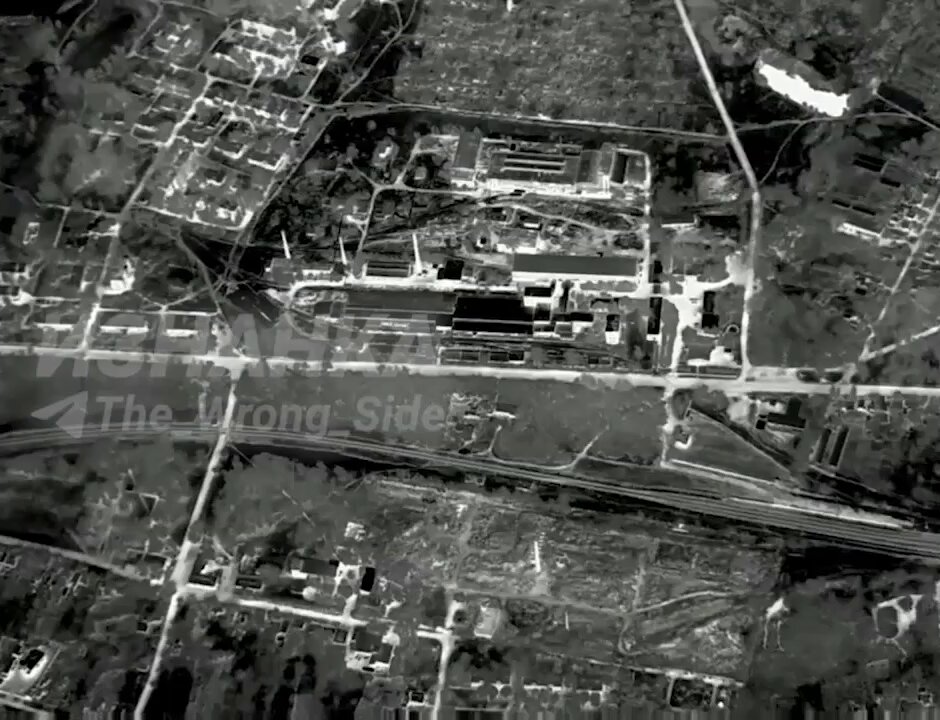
xmin=0 ymin=2 xmax=146 ymax=208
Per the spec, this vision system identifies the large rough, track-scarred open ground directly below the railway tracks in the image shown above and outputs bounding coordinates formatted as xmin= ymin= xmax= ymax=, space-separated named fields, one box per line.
xmin=198 ymin=456 xmax=779 ymax=685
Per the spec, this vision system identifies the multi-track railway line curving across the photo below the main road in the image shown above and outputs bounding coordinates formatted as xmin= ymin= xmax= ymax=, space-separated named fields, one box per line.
xmin=0 ymin=423 xmax=940 ymax=564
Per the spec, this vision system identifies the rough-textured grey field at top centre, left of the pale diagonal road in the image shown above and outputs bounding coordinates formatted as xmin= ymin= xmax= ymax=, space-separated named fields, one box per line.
xmin=395 ymin=0 xmax=713 ymax=125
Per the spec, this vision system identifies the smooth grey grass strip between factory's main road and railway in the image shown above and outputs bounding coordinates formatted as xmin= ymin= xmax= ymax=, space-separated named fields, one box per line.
xmin=238 ymin=373 xmax=665 ymax=465
